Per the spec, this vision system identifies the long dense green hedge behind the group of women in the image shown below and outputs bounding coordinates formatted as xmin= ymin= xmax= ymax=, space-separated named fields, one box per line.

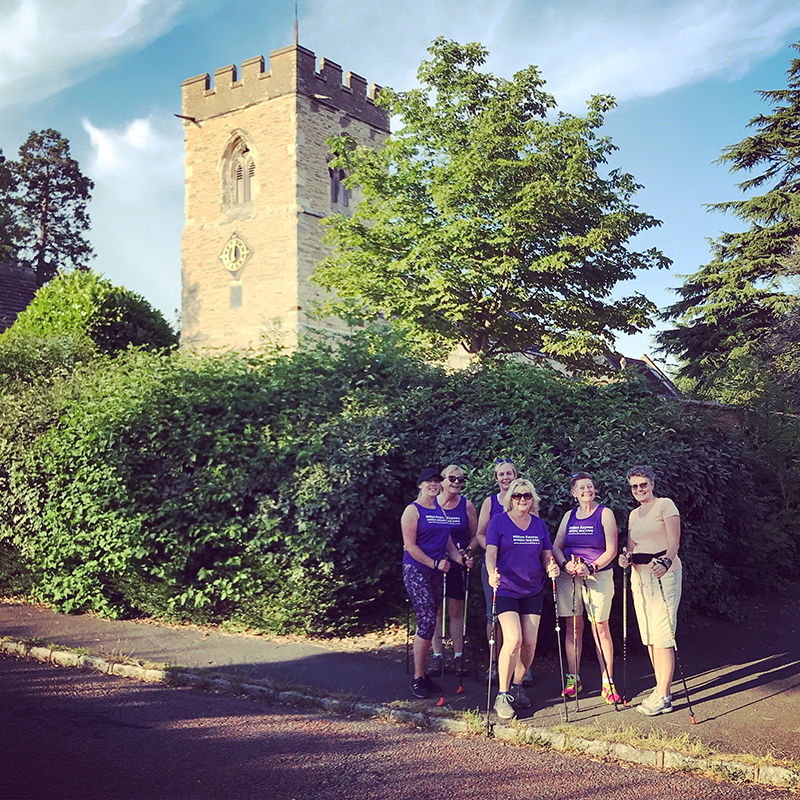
xmin=0 ymin=332 xmax=800 ymax=632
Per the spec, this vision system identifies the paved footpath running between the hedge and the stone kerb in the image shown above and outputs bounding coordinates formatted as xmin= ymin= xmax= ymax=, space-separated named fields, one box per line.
xmin=0 ymin=597 xmax=800 ymax=762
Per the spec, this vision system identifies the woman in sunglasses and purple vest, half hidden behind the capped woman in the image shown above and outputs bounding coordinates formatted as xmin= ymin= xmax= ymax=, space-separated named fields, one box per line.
xmin=431 ymin=464 xmax=478 ymax=676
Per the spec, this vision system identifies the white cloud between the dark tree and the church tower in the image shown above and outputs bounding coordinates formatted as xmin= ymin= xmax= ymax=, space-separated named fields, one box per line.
xmin=83 ymin=115 xmax=184 ymax=320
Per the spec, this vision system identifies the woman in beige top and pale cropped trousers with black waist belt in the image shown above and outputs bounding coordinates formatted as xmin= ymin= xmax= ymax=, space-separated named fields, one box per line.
xmin=619 ymin=466 xmax=682 ymax=717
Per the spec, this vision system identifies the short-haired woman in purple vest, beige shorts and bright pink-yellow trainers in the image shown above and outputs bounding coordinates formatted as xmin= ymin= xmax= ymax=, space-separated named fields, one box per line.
xmin=553 ymin=472 xmax=622 ymax=704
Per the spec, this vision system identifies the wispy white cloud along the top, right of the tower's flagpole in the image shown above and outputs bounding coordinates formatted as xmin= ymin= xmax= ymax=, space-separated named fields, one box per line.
xmin=300 ymin=0 xmax=800 ymax=111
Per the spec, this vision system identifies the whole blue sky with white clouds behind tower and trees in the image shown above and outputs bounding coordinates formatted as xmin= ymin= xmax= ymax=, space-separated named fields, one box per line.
xmin=0 ymin=0 xmax=800 ymax=356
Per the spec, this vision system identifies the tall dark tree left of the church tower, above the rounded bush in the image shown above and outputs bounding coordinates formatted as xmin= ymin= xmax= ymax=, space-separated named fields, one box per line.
xmin=15 ymin=128 xmax=94 ymax=286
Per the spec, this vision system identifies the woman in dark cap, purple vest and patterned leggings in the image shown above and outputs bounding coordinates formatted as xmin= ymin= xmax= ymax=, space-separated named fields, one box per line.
xmin=400 ymin=467 xmax=472 ymax=698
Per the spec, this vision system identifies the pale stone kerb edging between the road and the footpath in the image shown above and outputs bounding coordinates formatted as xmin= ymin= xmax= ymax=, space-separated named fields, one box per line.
xmin=0 ymin=640 xmax=800 ymax=789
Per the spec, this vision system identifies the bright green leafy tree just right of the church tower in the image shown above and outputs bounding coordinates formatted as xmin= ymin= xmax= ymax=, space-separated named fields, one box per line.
xmin=313 ymin=38 xmax=669 ymax=363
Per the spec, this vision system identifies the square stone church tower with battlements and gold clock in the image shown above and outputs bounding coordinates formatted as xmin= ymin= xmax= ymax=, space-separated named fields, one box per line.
xmin=181 ymin=44 xmax=389 ymax=348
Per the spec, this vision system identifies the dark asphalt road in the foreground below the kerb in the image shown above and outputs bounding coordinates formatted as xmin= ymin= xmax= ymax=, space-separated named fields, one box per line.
xmin=0 ymin=658 xmax=797 ymax=800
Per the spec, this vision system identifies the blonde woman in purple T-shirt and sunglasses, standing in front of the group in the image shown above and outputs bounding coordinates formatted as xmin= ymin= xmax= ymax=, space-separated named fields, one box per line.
xmin=486 ymin=478 xmax=559 ymax=719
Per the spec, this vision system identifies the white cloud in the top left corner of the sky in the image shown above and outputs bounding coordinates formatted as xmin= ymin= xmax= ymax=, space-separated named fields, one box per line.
xmin=0 ymin=0 xmax=192 ymax=108
